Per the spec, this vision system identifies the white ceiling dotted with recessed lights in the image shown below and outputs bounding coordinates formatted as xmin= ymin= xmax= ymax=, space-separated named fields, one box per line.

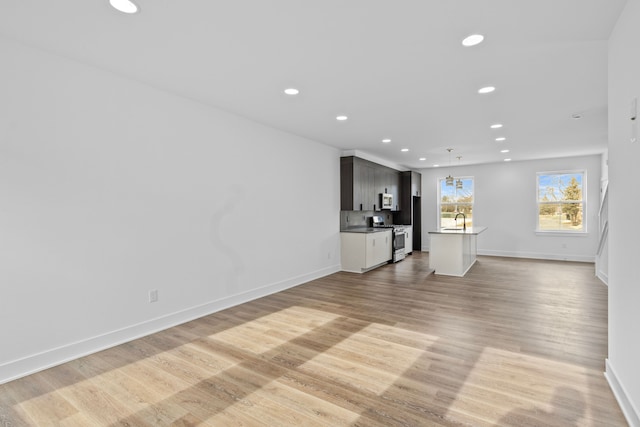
xmin=0 ymin=0 xmax=626 ymax=168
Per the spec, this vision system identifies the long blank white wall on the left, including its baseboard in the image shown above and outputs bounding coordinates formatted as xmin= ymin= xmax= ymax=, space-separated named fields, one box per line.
xmin=0 ymin=38 xmax=340 ymax=383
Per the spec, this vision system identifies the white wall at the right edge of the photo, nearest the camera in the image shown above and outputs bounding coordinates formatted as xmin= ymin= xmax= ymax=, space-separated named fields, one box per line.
xmin=607 ymin=0 xmax=640 ymax=426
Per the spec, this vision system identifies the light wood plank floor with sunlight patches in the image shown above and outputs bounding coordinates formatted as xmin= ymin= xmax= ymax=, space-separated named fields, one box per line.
xmin=0 ymin=253 xmax=626 ymax=427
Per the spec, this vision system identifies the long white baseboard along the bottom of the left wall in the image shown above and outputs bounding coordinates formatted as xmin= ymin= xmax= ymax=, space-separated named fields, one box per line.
xmin=0 ymin=265 xmax=340 ymax=384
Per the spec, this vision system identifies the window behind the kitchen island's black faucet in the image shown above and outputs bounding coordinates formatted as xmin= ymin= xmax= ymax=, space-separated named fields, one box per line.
xmin=438 ymin=177 xmax=473 ymax=228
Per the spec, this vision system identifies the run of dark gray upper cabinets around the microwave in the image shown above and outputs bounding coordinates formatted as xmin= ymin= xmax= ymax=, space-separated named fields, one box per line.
xmin=340 ymin=156 xmax=400 ymax=211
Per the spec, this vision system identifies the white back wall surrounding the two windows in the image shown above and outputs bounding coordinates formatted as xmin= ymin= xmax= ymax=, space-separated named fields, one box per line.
xmin=420 ymin=155 xmax=600 ymax=262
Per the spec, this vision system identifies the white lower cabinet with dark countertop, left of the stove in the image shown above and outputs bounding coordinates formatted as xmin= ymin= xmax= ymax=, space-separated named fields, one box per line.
xmin=340 ymin=230 xmax=392 ymax=273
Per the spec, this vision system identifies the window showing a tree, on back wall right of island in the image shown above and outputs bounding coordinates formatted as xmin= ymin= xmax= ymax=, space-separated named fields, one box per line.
xmin=537 ymin=171 xmax=586 ymax=232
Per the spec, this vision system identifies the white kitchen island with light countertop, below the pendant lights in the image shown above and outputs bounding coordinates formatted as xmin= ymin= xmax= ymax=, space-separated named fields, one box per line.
xmin=429 ymin=227 xmax=487 ymax=277
